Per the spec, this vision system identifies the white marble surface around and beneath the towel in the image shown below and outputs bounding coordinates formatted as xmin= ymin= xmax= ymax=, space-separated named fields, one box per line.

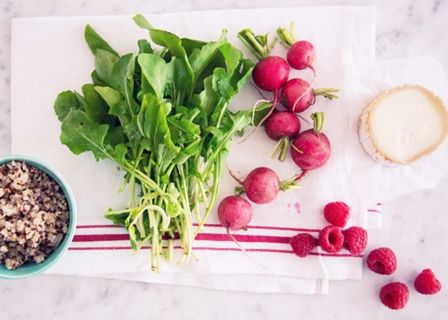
xmin=0 ymin=0 xmax=448 ymax=320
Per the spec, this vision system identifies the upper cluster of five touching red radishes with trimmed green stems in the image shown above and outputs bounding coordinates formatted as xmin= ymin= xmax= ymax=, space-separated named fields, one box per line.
xmin=238 ymin=25 xmax=338 ymax=177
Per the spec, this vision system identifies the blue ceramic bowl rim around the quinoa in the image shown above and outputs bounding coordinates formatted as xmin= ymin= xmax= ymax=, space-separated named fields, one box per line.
xmin=0 ymin=155 xmax=76 ymax=279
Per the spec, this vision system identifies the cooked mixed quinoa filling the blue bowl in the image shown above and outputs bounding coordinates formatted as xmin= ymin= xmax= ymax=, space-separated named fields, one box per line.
xmin=0 ymin=161 xmax=69 ymax=269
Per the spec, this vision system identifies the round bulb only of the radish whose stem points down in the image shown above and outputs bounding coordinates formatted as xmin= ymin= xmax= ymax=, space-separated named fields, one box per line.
xmin=264 ymin=111 xmax=300 ymax=141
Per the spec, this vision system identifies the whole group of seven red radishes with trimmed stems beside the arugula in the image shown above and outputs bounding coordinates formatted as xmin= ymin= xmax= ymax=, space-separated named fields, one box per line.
xmin=218 ymin=24 xmax=338 ymax=252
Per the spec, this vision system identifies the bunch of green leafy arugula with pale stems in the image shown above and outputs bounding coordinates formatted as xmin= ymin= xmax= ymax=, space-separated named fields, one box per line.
xmin=54 ymin=15 xmax=262 ymax=271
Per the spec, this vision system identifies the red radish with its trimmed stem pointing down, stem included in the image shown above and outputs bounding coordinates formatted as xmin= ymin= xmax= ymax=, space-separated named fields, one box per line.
xmin=264 ymin=111 xmax=300 ymax=161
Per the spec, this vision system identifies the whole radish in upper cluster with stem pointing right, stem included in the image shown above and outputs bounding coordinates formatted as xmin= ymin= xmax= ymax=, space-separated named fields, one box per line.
xmin=282 ymin=78 xmax=339 ymax=112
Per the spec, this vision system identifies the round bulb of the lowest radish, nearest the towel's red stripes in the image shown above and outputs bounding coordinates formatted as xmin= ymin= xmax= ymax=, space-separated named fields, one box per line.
xmin=218 ymin=196 xmax=253 ymax=230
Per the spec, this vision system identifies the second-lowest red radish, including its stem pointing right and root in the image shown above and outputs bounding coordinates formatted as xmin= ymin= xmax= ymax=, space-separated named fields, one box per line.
xmin=231 ymin=167 xmax=297 ymax=204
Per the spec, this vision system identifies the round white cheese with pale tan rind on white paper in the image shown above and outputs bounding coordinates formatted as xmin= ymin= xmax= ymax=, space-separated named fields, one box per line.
xmin=359 ymin=85 xmax=448 ymax=164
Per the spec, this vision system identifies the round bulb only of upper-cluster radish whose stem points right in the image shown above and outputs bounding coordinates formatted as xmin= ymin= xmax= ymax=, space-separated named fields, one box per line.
xmin=282 ymin=78 xmax=315 ymax=113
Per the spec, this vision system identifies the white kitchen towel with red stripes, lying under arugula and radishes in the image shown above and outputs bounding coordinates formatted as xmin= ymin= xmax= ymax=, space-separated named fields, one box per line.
xmin=11 ymin=7 xmax=375 ymax=293
